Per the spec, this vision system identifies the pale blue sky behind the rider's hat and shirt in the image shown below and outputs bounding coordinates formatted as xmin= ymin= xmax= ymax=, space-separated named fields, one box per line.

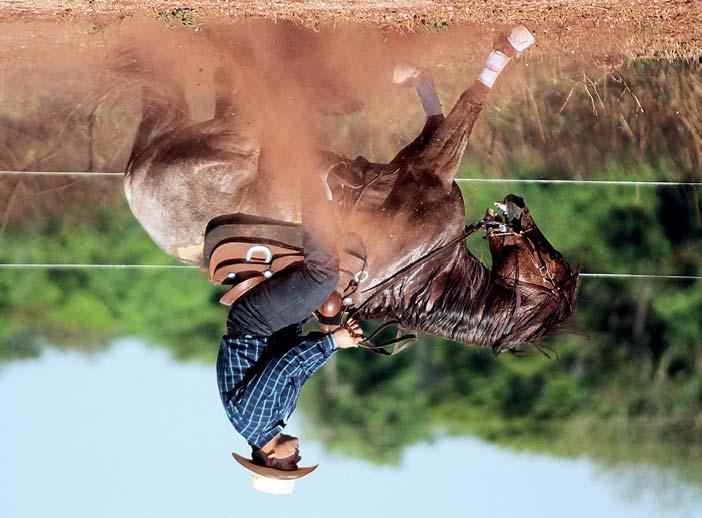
xmin=0 ymin=341 xmax=702 ymax=518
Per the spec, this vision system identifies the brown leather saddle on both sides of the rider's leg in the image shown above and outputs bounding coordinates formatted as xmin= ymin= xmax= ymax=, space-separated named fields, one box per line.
xmin=200 ymin=214 xmax=368 ymax=331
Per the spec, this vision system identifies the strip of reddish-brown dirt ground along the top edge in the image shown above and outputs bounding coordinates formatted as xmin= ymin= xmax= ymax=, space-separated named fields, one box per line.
xmin=0 ymin=0 xmax=702 ymax=59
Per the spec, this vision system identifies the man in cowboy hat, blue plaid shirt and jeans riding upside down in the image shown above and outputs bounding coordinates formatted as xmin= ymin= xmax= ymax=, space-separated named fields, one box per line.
xmin=217 ymin=170 xmax=364 ymax=494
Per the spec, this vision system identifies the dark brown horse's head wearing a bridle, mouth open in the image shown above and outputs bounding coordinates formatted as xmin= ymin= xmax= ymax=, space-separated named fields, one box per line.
xmin=478 ymin=194 xmax=580 ymax=354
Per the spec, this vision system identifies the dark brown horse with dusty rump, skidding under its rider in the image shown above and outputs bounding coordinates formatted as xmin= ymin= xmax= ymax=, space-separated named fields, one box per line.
xmin=125 ymin=27 xmax=579 ymax=354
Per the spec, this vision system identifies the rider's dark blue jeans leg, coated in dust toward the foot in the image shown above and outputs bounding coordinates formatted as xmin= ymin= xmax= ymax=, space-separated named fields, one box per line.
xmin=227 ymin=179 xmax=339 ymax=337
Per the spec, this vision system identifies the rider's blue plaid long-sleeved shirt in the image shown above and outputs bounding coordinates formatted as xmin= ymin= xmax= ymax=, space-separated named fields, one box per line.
xmin=217 ymin=324 xmax=336 ymax=448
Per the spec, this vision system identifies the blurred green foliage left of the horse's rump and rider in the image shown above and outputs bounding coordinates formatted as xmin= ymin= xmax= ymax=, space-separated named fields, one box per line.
xmin=0 ymin=201 xmax=224 ymax=360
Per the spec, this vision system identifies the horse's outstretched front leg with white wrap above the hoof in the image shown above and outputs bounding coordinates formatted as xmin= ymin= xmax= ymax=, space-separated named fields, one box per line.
xmin=409 ymin=26 xmax=534 ymax=188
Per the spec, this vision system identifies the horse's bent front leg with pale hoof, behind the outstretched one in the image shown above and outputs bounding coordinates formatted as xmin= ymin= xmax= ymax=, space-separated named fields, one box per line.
xmin=390 ymin=64 xmax=444 ymax=164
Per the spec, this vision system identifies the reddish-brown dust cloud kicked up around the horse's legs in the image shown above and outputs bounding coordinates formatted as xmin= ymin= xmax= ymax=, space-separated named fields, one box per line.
xmin=106 ymin=21 xmax=486 ymax=193
